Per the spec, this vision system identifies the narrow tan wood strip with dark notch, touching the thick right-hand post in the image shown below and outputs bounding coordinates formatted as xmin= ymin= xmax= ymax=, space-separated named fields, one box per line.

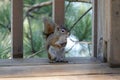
xmin=103 ymin=0 xmax=110 ymax=61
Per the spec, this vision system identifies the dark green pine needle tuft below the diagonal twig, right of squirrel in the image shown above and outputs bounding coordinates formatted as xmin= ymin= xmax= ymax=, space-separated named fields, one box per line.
xmin=73 ymin=12 xmax=92 ymax=41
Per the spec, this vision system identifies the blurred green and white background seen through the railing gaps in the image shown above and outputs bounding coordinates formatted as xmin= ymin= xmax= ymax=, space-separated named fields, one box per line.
xmin=0 ymin=0 xmax=92 ymax=59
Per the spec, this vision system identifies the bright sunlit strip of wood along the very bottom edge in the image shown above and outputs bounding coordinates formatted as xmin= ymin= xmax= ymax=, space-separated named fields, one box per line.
xmin=0 ymin=74 xmax=120 ymax=80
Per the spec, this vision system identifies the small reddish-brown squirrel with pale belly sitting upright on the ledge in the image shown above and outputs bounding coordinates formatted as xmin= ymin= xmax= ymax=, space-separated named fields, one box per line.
xmin=43 ymin=18 xmax=69 ymax=63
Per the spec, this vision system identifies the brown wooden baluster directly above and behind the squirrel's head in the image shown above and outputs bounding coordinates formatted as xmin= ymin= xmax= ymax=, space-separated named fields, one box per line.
xmin=53 ymin=0 xmax=64 ymax=25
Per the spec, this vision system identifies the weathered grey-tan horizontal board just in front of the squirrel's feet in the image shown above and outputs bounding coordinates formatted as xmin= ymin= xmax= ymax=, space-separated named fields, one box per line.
xmin=0 ymin=63 xmax=120 ymax=80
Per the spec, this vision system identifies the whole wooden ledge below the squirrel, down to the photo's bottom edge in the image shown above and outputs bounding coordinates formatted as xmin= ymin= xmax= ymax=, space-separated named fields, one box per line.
xmin=0 ymin=59 xmax=120 ymax=80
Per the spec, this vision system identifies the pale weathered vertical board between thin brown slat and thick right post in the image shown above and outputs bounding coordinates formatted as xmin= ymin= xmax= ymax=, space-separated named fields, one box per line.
xmin=97 ymin=0 xmax=110 ymax=61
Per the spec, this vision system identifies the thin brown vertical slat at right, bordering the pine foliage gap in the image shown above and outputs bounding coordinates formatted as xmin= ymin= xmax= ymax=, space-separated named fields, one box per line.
xmin=92 ymin=0 xmax=98 ymax=57
